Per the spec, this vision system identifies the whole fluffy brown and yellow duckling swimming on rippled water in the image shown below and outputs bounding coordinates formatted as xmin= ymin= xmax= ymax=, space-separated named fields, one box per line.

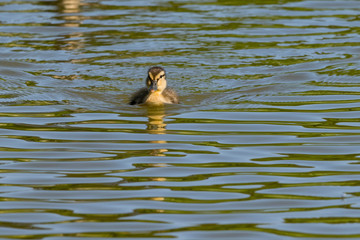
xmin=129 ymin=67 xmax=179 ymax=105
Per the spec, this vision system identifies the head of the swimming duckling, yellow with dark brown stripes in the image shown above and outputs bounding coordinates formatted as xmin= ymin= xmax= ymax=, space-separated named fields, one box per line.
xmin=146 ymin=67 xmax=166 ymax=93
